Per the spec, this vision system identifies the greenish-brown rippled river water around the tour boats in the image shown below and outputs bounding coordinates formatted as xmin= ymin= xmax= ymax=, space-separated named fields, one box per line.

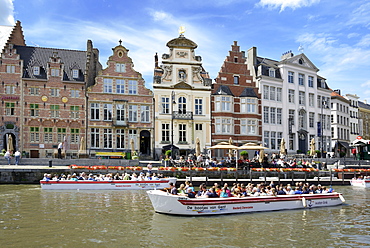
xmin=0 ymin=185 xmax=370 ymax=248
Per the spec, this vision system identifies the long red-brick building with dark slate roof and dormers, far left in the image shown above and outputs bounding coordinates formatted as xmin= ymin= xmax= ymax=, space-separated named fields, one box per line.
xmin=0 ymin=22 xmax=99 ymax=158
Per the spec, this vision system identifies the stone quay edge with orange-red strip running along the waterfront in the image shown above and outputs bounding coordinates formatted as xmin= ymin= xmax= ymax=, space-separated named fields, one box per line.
xmin=0 ymin=158 xmax=370 ymax=186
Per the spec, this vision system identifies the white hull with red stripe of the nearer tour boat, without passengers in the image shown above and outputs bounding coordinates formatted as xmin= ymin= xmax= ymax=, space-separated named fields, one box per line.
xmin=147 ymin=190 xmax=345 ymax=216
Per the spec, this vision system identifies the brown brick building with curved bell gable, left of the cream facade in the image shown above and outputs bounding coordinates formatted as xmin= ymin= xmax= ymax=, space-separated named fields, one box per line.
xmin=87 ymin=41 xmax=154 ymax=157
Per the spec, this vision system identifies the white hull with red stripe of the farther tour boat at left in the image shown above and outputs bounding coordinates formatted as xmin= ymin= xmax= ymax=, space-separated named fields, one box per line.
xmin=40 ymin=178 xmax=177 ymax=190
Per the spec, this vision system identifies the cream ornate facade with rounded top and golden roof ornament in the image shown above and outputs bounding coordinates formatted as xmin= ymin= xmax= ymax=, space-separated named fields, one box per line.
xmin=153 ymin=34 xmax=212 ymax=158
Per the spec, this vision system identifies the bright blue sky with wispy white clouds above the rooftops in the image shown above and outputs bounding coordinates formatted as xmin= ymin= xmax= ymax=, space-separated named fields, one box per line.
xmin=0 ymin=0 xmax=370 ymax=102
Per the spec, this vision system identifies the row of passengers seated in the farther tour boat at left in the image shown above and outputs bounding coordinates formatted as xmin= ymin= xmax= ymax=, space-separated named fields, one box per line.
xmin=42 ymin=172 xmax=163 ymax=181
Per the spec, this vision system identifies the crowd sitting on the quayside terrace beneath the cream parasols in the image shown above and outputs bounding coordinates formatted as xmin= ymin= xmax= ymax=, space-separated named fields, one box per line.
xmin=163 ymin=153 xmax=326 ymax=169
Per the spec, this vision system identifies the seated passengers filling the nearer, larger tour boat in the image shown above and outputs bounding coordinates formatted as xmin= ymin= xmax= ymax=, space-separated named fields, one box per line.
xmin=165 ymin=181 xmax=334 ymax=198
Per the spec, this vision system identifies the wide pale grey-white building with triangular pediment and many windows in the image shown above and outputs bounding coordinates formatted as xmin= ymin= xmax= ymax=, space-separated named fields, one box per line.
xmin=247 ymin=47 xmax=331 ymax=153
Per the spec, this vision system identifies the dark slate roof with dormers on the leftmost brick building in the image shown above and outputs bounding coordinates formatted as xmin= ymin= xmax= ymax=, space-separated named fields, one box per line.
xmin=14 ymin=46 xmax=87 ymax=82
